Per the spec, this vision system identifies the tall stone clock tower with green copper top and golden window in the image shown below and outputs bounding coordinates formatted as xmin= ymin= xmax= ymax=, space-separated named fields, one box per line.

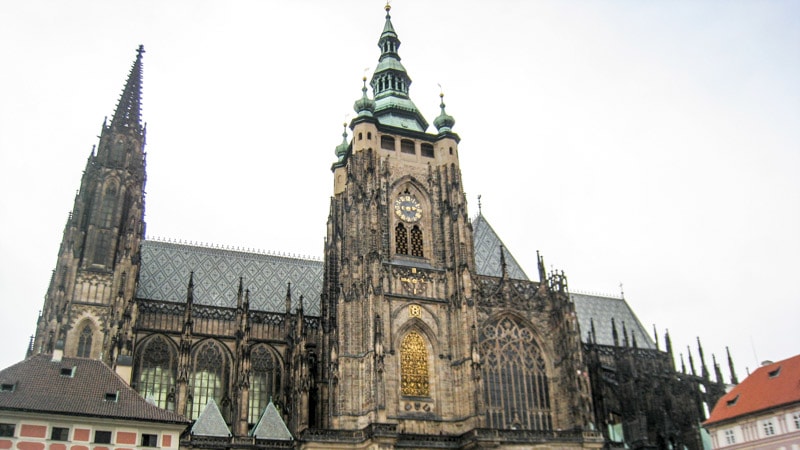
xmin=318 ymin=5 xmax=481 ymax=435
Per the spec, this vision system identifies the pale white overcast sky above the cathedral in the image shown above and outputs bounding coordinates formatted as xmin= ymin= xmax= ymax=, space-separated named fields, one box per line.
xmin=0 ymin=0 xmax=800 ymax=379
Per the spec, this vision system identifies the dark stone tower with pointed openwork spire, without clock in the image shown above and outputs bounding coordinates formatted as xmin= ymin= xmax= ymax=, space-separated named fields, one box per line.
xmin=30 ymin=46 xmax=146 ymax=370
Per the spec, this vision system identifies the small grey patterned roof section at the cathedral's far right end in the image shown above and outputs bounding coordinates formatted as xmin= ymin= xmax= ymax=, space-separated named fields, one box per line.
xmin=570 ymin=294 xmax=656 ymax=349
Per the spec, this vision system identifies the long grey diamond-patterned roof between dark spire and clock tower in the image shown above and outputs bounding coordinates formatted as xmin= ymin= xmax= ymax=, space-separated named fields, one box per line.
xmin=136 ymin=240 xmax=322 ymax=316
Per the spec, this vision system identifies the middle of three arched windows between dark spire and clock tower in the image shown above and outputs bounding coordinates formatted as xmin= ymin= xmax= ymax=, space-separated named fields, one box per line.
xmin=189 ymin=340 xmax=228 ymax=420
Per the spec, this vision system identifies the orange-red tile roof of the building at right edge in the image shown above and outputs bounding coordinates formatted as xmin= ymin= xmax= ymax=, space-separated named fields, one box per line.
xmin=704 ymin=355 xmax=800 ymax=425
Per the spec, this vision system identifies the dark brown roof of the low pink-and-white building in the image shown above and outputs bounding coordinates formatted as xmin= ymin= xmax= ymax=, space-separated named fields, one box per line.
xmin=0 ymin=355 xmax=189 ymax=425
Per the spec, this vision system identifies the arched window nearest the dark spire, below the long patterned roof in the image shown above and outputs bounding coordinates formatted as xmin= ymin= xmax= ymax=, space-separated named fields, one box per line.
xmin=136 ymin=336 xmax=177 ymax=410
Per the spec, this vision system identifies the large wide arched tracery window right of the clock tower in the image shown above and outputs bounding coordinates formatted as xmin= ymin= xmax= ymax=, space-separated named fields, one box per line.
xmin=480 ymin=317 xmax=553 ymax=430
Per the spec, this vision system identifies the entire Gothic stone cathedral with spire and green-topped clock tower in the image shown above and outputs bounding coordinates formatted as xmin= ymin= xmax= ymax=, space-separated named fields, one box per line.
xmin=29 ymin=5 xmax=735 ymax=449
